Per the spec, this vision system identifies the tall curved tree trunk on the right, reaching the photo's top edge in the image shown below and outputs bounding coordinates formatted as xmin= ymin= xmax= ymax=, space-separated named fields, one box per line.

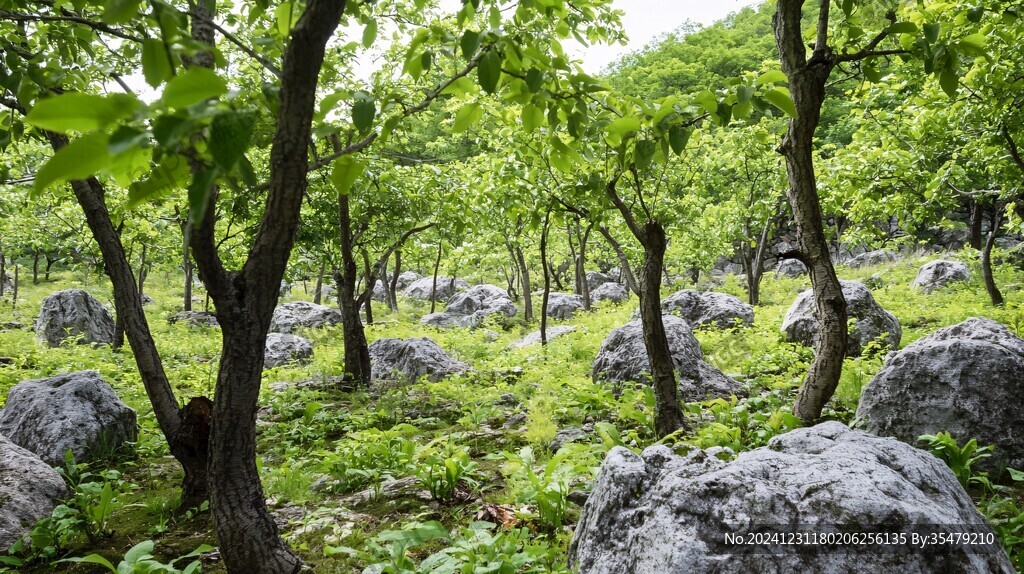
xmin=773 ymin=0 xmax=847 ymax=424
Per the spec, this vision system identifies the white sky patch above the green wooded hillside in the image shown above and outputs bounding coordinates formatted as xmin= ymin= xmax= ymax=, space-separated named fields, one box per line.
xmin=577 ymin=0 xmax=762 ymax=74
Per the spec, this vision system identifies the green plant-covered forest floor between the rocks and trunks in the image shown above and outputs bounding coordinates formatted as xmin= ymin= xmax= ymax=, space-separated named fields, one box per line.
xmin=0 ymin=248 xmax=1024 ymax=573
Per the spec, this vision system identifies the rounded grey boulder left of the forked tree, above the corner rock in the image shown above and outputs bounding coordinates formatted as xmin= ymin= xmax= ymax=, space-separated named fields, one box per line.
xmin=0 ymin=370 xmax=138 ymax=467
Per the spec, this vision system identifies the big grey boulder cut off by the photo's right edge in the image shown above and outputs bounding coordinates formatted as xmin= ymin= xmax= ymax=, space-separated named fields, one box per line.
xmin=857 ymin=317 xmax=1024 ymax=469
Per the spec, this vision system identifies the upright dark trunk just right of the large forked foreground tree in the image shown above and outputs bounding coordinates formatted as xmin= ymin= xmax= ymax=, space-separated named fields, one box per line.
xmin=335 ymin=194 xmax=372 ymax=388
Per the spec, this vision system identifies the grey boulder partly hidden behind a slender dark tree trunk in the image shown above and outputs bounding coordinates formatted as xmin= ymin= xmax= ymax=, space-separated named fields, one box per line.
xmin=591 ymin=315 xmax=740 ymax=402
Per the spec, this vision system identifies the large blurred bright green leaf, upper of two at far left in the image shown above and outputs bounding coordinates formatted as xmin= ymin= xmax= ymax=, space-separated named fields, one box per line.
xmin=25 ymin=92 xmax=139 ymax=133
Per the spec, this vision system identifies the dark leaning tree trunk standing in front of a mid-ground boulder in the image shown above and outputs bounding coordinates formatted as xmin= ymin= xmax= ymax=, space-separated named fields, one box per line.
xmin=640 ymin=221 xmax=684 ymax=438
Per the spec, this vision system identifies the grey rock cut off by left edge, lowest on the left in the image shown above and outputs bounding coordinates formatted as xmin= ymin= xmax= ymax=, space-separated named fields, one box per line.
xmin=0 ymin=435 xmax=68 ymax=554
